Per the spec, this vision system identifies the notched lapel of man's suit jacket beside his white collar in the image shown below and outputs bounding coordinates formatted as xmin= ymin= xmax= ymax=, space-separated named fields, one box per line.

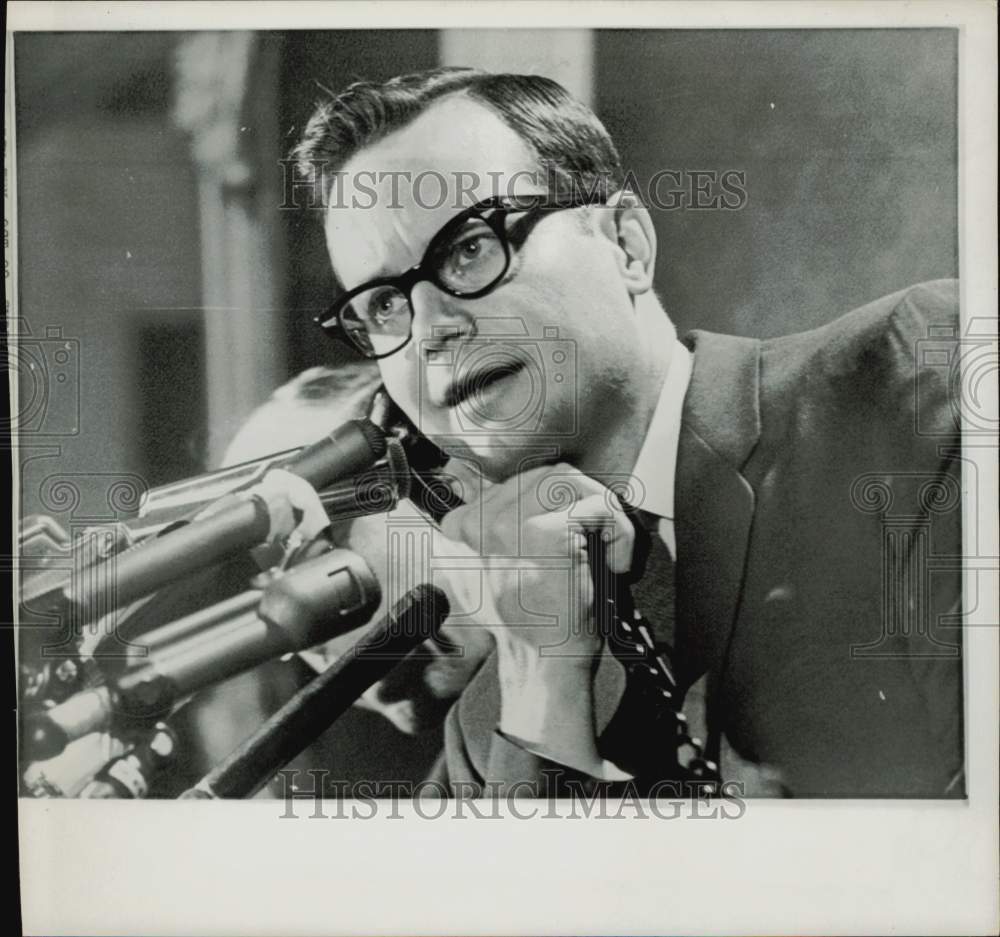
xmin=674 ymin=332 xmax=760 ymax=687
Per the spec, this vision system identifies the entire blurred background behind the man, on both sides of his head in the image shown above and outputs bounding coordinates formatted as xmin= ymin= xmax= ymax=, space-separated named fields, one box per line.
xmin=14 ymin=30 xmax=958 ymax=777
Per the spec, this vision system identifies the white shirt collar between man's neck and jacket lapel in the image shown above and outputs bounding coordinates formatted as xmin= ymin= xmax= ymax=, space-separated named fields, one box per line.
xmin=632 ymin=338 xmax=693 ymax=559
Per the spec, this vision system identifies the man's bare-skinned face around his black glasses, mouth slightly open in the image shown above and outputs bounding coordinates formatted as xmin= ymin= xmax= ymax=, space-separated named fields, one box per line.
xmin=326 ymin=96 xmax=637 ymax=479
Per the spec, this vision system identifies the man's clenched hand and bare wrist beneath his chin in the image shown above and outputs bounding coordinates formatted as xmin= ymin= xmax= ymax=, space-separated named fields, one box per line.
xmin=442 ymin=464 xmax=634 ymax=765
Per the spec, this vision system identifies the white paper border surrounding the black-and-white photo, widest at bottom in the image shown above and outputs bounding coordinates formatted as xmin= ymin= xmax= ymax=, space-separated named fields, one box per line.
xmin=5 ymin=0 xmax=1000 ymax=937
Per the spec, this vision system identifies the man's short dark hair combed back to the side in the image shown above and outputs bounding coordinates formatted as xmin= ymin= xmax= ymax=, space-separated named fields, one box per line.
xmin=291 ymin=68 xmax=623 ymax=200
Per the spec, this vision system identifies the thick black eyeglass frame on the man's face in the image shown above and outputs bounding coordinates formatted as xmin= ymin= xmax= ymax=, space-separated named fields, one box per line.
xmin=313 ymin=192 xmax=607 ymax=361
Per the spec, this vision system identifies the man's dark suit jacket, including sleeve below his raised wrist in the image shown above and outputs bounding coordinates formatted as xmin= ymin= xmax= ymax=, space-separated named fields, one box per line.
xmin=436 ymin=281 xmax=964 ymax=797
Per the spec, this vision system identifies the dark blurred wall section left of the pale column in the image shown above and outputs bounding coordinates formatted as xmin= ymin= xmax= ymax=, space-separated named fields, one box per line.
xmin=15 ymin=33 xmax=205 ymax=516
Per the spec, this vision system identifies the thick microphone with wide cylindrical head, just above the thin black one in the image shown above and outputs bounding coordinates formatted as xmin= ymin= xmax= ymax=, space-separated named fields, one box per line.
xmin=24 ymin=550 xmax=381 ymax=761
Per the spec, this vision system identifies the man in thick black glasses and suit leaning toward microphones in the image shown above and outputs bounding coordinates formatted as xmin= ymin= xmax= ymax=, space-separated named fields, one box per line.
xmin=295 ymin=69 xmax=963 ymax=796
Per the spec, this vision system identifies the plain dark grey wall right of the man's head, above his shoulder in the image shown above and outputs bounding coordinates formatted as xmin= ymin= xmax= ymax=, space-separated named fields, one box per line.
xmin=594 ymin=30 xmax=958 ymax=337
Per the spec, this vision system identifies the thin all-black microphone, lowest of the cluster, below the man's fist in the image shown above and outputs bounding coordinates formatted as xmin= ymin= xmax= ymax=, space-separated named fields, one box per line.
xmin=181 ymin=584 xmax=450 ymax=799
